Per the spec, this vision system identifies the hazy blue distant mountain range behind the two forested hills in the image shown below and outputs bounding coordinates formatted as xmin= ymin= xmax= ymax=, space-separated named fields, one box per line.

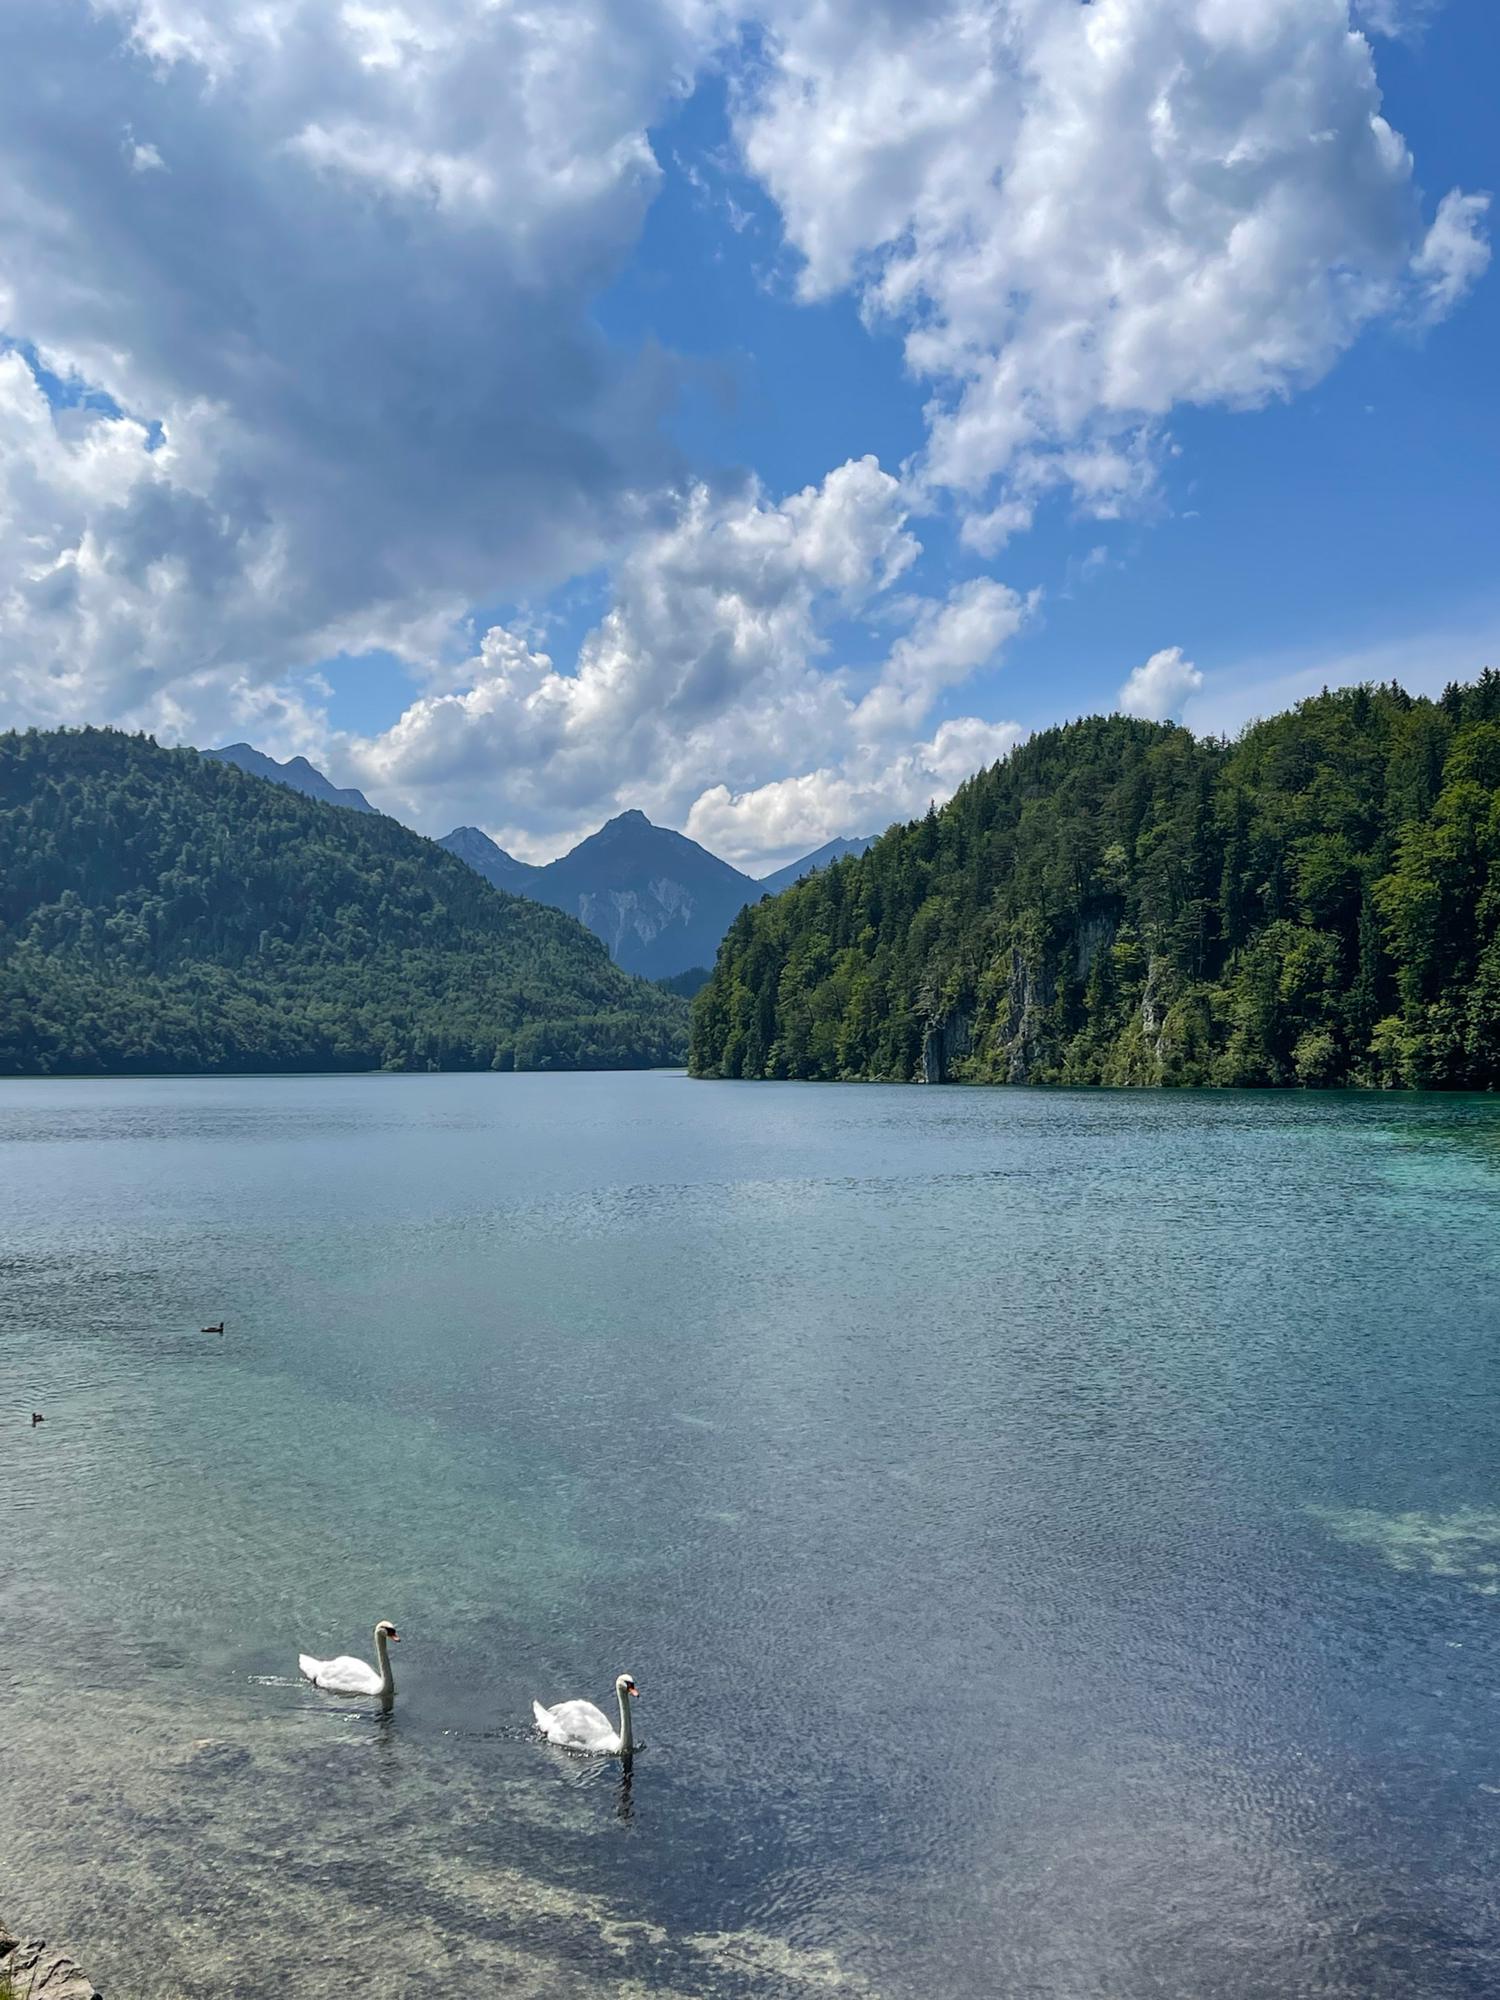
xmin=204 ymin=744 xmax=874 ymax=980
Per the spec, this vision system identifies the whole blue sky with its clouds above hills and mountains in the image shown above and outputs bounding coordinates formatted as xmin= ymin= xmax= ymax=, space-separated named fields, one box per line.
xmin=0 ymin=0 xmax=1500 ymax=866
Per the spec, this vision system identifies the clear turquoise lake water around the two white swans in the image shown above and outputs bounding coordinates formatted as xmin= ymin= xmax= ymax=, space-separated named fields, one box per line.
xmin=0 ymin=1074 xmax=1500 ymax=2000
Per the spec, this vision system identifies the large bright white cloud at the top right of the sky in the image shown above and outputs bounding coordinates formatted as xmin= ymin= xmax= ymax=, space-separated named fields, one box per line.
xmin=738 ymin=0 xmax=1486 ymax=516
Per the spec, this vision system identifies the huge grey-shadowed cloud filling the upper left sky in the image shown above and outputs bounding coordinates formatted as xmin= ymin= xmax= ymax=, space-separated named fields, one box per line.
xmin=0 ymin=0 xmax=710 ymax=724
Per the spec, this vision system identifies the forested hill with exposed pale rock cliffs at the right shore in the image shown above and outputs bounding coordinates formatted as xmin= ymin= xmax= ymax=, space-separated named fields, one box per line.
xmin=692 ymin=670 xmax=1500 ymax=1090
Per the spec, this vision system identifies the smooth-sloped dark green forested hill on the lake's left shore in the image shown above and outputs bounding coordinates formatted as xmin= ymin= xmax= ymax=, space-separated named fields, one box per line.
xmin=0 ymin=730 xmax=686 ymax=1076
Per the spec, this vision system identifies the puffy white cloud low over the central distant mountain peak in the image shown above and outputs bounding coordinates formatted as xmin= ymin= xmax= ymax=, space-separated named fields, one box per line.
xmin=344 ymin=458 xmax=1028 ymax=858
